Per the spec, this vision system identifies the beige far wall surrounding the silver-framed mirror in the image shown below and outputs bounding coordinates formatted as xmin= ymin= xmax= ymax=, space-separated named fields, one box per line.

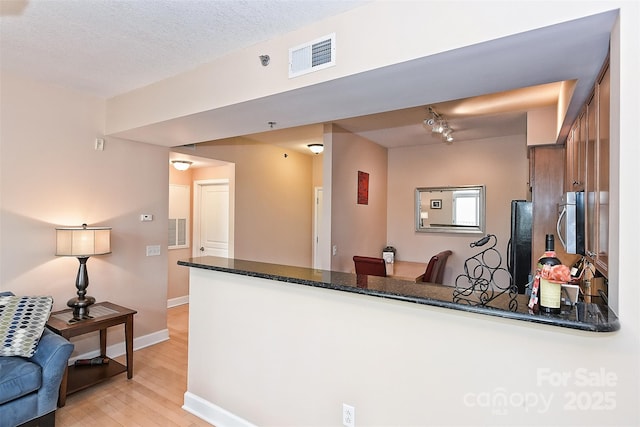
xmin=387 ymin=135 xmax=530 ymax=284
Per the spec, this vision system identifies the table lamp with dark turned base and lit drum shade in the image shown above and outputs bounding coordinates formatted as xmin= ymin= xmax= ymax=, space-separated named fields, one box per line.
xmin=56 ymin=224 xmax=111 ymax=322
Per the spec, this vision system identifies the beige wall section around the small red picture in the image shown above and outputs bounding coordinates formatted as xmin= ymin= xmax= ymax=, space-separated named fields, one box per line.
xmin=331 ymin=126 xmax=387 ymax=272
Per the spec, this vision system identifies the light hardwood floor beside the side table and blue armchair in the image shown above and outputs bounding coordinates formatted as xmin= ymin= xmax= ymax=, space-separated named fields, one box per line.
xmin=56 ymin=304 xmax=210 ymax=427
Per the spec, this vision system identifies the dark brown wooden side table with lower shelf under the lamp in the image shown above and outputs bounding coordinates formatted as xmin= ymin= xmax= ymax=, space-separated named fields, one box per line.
xmin=47 ymin=302 xmax=137 ymax=407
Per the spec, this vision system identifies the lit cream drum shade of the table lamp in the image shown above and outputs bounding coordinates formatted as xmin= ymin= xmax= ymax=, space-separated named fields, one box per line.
xmin=56 ymin=224 xmax=111 ymax=257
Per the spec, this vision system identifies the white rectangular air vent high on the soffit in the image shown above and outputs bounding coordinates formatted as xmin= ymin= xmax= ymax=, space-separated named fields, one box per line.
xmin=289 ymin=33 xmax=336 ymax=78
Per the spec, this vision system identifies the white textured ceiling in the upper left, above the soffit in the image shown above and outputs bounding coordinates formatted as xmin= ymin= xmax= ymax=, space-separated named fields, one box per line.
xmin=0 ymin=0 xmax=366 ymax=98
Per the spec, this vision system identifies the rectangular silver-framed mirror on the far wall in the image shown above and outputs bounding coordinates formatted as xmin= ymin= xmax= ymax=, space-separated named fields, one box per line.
xmin=416 ymin=185 xmax=485 ymax=234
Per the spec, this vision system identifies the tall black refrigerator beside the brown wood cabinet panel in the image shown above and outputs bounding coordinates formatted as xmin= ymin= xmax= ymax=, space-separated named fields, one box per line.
xmin=507 ymin=200 xmax=533 ymax=294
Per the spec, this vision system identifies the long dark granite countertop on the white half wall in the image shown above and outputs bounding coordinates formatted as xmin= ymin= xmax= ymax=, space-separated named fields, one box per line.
xmin=178 ymin=256 xmax=620 ymax=332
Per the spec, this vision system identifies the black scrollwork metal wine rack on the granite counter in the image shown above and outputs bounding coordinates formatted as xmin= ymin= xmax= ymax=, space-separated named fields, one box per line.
xmin=453 ymin=234 xmax=518 ymax=311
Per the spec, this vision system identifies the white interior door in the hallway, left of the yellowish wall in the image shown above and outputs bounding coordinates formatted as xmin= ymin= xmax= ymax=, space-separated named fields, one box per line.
xmin=194 ymin=182 xmax=229 ymax=258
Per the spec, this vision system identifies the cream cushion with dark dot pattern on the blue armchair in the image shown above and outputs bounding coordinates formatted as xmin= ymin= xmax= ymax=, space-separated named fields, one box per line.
xmin=0 ymin=296 xmax=53 ymax=357
